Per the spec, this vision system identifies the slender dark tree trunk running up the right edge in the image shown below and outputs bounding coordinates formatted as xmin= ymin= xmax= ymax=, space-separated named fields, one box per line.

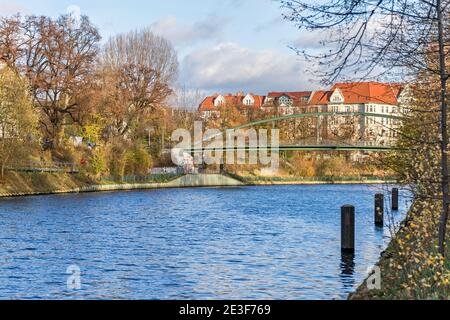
xmin=436 ymin=0 xmax=449 ymax=255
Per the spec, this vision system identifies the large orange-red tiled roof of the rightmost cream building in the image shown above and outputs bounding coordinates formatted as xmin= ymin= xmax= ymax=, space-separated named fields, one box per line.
xmin=331 ymin=82 xmax=402 ymax=105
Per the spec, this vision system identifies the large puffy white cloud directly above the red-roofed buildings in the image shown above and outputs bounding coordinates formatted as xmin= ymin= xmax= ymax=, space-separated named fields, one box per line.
xmin=181 ymin=43 xmax=317 ymax=94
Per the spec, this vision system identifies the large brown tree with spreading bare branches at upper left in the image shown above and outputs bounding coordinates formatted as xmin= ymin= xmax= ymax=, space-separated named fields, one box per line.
xmin=0 ymin=15 xmax=100 ymax=148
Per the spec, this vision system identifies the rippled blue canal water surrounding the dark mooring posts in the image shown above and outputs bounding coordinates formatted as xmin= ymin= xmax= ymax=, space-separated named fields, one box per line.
xmin=0 ymin=185 xmax=409 ymax=300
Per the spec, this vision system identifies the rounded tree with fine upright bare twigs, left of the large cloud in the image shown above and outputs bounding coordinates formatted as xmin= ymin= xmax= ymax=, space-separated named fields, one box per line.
xmin=101 ymin=30 xmax=178 ymax=137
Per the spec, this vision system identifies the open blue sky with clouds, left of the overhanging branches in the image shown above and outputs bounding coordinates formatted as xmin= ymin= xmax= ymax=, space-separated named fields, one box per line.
xmin=0 ymin=0 xmax=324 ymax=95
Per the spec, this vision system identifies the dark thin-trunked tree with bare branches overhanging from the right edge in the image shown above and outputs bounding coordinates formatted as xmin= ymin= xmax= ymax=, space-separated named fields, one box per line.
xmin=280 ymin=0 xmax=450 ymax=254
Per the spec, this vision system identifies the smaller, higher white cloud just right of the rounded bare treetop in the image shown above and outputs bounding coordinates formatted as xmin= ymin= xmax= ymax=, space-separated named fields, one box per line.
xmin=150 ymin=15 xmax=228 ymax=46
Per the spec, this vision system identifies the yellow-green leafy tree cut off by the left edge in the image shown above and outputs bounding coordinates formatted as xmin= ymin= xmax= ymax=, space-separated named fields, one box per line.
xmin=0 ymin=66 xmax=38 ymax=177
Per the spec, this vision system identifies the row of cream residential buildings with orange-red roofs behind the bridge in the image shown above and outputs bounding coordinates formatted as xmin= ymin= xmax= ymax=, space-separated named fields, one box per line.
xmin=199 ymin=82 xmax=405 ymax=145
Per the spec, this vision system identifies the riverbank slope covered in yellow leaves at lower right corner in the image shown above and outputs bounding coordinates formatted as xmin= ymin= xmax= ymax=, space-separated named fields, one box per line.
xmin=349 ymin=201 xmax=450 ymax=300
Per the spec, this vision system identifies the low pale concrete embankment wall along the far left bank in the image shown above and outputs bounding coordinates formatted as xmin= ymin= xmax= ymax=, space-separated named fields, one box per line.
xmin=0 ymin=174 xmax=244 ymax=197
